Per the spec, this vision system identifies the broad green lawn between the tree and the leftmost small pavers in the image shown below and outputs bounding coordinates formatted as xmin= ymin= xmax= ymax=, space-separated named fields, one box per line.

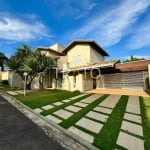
xmin=15 ymin=90 xmax=80 ymax=108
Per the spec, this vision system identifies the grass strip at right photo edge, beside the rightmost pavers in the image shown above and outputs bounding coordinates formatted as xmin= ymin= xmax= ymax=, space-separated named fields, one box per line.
xmin=140 ymin=97 xmax=150 ymax=150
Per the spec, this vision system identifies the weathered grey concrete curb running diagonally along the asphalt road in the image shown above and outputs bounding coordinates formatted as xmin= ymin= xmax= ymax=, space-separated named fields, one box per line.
xmin=0 ymin=91 xmax=99 ymax=150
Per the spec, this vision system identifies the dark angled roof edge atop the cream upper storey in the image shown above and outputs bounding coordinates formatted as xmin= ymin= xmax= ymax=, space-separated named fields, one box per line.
xmin=62 ymin=40 xmax=109 ymax=56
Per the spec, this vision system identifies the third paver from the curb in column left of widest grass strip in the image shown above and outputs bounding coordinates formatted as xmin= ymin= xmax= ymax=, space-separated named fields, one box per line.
xmin=86 ymin=111 xmax=108 ymax=122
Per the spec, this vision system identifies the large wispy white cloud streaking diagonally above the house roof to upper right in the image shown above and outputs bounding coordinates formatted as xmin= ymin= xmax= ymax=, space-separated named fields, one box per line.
xmin=70 ymin=0 xmax=150 ymax=46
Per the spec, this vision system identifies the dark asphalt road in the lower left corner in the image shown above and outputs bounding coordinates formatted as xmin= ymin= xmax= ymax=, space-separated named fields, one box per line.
xmin=0 ymin=96 xmax=64 ymax=150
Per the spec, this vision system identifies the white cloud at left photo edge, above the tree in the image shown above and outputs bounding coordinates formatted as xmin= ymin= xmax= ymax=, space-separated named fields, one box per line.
xmin=0 ymin=13 xmax=48 ymax=41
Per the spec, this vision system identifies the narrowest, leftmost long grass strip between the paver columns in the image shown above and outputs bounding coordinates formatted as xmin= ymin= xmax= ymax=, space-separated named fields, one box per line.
xmin=41 ymin=94 xmax=92 ymax=116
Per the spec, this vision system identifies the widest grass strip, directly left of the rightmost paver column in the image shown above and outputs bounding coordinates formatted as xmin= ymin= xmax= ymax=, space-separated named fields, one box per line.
xmin=93 ymin=95 xmax=128 ymax=150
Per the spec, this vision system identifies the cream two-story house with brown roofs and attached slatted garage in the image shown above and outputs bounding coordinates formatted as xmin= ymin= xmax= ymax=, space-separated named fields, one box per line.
xmin=38 ymin=40 xmax=150 ymax=92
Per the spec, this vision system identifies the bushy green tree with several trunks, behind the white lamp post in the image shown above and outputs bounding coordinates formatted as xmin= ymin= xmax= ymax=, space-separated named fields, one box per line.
xmin=8 ymin=44 xmax=54 ymax=89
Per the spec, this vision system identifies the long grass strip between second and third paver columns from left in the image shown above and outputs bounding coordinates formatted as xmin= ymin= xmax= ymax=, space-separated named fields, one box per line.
xmin=60 ymin=95 xmax=108 ymax=129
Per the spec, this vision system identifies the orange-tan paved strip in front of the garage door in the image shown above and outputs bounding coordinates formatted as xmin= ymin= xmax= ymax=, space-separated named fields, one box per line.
xmin=87 ymin=89 xmax=150 ymax=97
